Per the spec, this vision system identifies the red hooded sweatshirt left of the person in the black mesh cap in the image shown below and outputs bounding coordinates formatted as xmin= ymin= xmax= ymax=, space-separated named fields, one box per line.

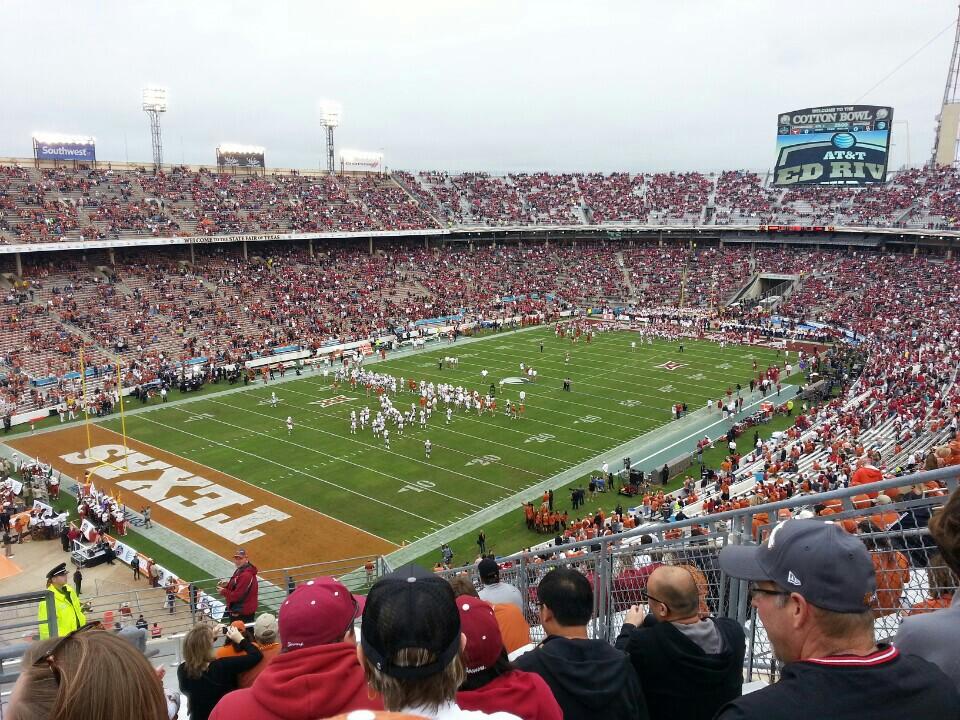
xmin=210 ymin=643 xmax=383 ymax=720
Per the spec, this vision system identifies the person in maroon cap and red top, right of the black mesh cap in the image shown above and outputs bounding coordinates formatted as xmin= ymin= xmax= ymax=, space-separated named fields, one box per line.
xmin=457 ymin=595 xmax=563 ymax=720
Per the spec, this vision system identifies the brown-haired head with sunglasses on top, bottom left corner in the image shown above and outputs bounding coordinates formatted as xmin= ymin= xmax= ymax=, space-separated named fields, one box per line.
xmin=6 ymin=624 xmax=167 ymax=720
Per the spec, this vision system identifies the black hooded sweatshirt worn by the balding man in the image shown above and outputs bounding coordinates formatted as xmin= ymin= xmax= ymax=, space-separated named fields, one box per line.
xmin=615 ymin=615 xmax=746 ymax=720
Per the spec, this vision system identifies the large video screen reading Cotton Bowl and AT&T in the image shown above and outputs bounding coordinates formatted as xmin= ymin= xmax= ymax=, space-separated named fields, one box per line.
xmin=773 ymin=105 xmax=893 ymax=187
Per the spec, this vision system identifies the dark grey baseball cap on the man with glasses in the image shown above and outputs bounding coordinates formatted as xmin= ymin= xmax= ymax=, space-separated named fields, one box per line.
xmin=719 ymin=520 xmax=877 ymax=613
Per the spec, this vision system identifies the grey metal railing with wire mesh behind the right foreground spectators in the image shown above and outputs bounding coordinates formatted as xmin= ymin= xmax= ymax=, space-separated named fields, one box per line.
xmin=443 ymin=466 xmax=960 ymax=681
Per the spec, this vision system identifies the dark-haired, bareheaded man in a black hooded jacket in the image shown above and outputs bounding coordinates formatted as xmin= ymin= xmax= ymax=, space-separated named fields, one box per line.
xmin=515 ymin=568 xmax=649 ymax=720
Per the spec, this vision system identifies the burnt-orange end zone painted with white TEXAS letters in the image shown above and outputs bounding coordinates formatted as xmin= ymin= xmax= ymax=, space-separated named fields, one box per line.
xmin=6 ymin=425 xmax=397 ymax=568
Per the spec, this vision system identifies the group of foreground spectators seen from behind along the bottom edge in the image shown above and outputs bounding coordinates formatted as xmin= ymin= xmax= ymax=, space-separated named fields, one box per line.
xmin=8 ymin=484 xmax=960 ymax=720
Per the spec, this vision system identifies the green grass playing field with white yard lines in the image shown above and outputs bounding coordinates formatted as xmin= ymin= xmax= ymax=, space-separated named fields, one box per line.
xmin=94 ymin=328 xmax=792 ymax=551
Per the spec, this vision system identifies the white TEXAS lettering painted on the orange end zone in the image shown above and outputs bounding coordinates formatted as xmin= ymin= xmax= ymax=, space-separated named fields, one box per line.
xmin=60 ymin=445 xmax=290 ymax=545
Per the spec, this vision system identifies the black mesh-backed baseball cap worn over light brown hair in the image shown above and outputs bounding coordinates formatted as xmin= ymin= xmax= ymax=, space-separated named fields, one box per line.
xmin=360 ymin=563 xmax=460 ymax=680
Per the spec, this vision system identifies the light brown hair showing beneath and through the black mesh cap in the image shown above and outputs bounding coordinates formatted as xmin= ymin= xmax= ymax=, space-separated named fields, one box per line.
xmin=363 ymin=648 xmax=467 ymax=711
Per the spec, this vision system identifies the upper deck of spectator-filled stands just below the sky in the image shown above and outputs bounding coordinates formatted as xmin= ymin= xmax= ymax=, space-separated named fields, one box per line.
xmin=0 ymin=164 xmax=960 ymax=244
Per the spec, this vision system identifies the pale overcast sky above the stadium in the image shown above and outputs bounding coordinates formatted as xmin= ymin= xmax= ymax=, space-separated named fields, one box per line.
xmin=0 ymin=0 xmax=957 ymax=172
